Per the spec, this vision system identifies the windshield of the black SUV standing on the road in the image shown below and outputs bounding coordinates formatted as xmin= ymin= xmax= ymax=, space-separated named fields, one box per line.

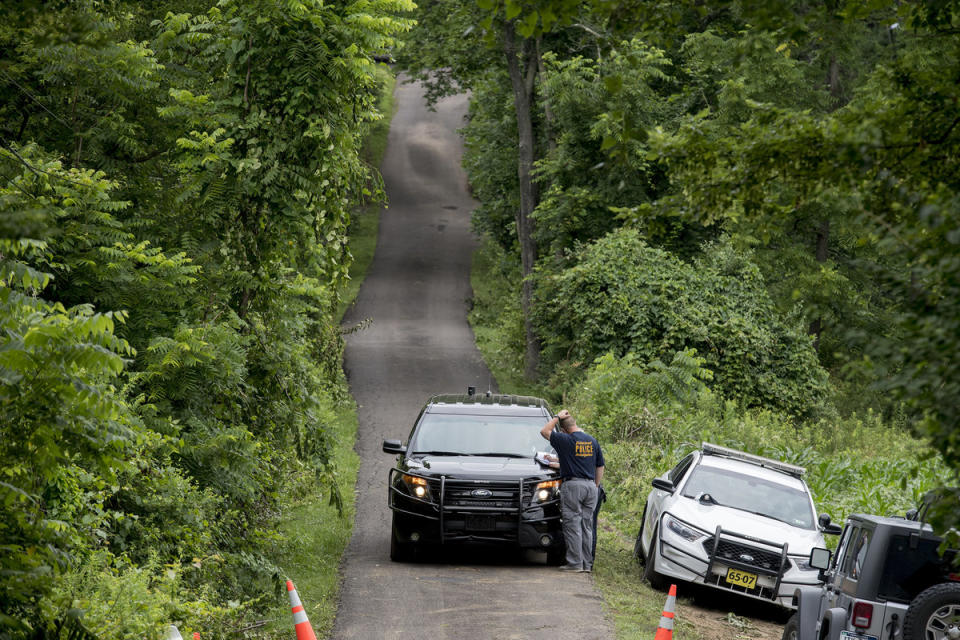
xmin=407 ymin=413 xmax=553 ymax=458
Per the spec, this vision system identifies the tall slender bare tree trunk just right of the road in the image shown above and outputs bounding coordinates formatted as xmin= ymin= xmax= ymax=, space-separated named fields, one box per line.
xmin=503 ymin=20 xmax=540 ymax=380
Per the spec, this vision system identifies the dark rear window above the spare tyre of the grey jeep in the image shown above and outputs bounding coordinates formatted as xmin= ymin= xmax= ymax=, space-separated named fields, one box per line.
xmin=877 ymin=535 xmax=942 ymax=603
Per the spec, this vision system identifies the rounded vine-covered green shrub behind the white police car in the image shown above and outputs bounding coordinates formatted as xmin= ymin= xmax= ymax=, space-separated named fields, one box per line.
xmin=534 ymin=229 xmax=827 ymax=416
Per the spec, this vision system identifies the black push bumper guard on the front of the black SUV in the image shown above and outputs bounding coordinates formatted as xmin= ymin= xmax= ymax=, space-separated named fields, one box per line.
xmin=387 ymin=468 xmax=560 ymax=544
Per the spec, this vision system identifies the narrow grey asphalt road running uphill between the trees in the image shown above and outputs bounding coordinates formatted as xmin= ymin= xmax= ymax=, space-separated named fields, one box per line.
xmin=333 ymin=84 xmax=613 ymax=640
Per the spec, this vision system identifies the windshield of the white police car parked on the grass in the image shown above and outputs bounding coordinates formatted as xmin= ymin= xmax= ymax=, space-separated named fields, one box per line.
xmin=683 ymin=466 xmax=813 ymax=529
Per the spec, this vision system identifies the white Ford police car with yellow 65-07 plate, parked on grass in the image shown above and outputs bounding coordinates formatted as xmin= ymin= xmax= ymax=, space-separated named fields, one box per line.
xmin=634 ymin=442 xmax=841 ymax=607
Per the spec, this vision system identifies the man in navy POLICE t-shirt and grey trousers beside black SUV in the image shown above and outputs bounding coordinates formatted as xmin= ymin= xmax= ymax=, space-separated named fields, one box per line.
xmin=540 ymin=409 xmax=604 ymax=573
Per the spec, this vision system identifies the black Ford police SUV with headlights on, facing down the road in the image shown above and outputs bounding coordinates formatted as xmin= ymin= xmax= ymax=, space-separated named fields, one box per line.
xmin=383 ymin=388 xmax=565 ymax=564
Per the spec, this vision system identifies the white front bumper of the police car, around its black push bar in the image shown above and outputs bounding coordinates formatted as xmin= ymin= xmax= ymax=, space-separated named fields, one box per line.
xmin=656 ymin=513 xmax=821 ymax=608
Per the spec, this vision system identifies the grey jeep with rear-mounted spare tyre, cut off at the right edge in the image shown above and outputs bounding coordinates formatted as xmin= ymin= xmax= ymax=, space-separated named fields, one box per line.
xmin=783 ymin=515 xmax=960 ymax=640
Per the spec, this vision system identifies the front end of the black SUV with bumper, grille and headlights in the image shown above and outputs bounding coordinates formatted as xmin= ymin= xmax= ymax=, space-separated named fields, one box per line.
xmin=388 ymin=469 xmax=563 ymax=551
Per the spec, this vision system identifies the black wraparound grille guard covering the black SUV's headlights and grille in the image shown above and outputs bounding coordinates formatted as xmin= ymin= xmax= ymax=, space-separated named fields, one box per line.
xmin=387 ymin=467 xmax=560 ymax=543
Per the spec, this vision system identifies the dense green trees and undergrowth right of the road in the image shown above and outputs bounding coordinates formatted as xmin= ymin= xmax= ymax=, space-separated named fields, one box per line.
xmin=406 ymin=0 xmax=960 ymax=544
